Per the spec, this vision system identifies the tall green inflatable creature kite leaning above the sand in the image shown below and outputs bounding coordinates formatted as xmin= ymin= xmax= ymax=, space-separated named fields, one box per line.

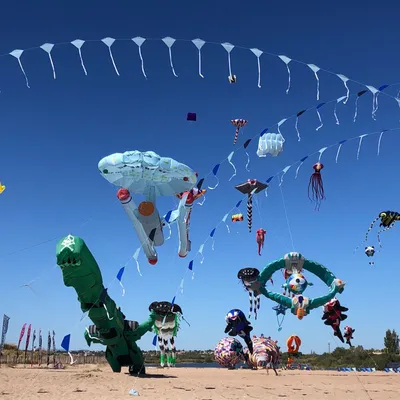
xmin=57 ymin=235 xmax=157 ymax=375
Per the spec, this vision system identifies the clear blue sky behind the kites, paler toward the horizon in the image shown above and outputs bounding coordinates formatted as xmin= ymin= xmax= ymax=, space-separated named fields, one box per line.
xmin=0 ymin=0 xmax=400 ymax=352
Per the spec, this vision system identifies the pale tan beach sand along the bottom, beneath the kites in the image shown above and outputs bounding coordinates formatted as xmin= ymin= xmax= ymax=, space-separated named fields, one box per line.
xmin=0 ymin=365 xmax=400 ymax=400
